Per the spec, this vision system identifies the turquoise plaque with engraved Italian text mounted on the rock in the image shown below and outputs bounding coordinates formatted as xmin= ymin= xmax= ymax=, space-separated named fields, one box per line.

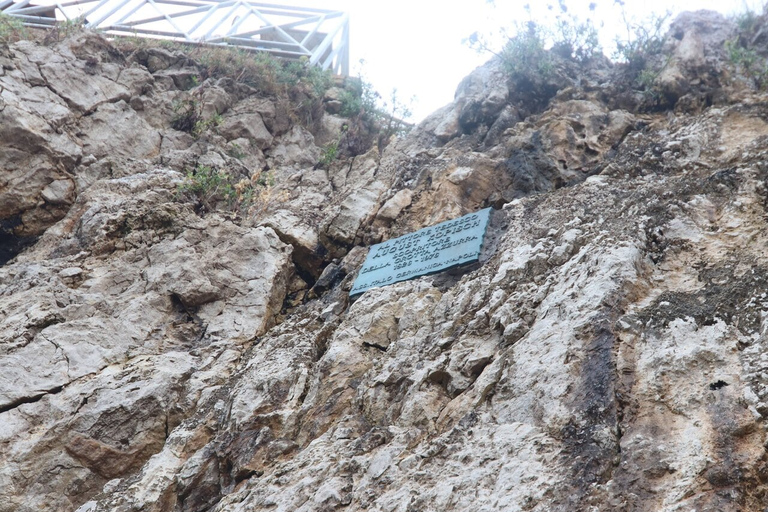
xmin=349 ymin=208 xmax=491 ymax=295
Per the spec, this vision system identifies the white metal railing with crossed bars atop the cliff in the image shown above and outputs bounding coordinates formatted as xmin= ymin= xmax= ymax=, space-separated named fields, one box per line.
xmin=0 ymin=0 xmax=349 ymax=75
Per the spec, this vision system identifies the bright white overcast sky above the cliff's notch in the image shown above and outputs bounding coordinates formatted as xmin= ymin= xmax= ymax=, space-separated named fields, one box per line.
xmin=314 ymin=0 xmax=761 ymax=122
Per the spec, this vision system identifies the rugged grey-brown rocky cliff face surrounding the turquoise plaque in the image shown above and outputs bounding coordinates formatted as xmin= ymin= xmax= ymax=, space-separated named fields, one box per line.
xmin=0 ymin=12 xmax=768 ymax=512
